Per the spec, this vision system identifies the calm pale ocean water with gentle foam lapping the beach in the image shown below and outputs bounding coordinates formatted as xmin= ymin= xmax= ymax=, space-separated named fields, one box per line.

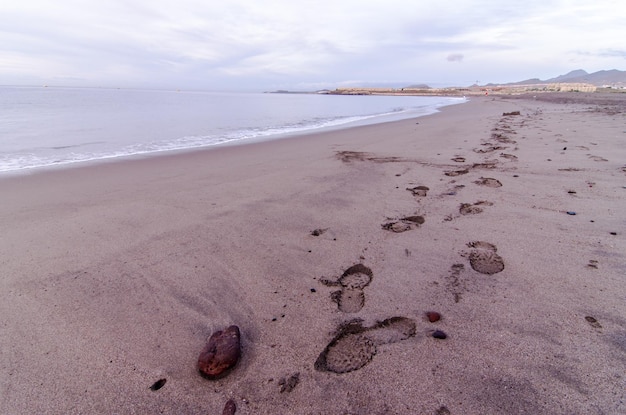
xmin=0 ymin=87 xmax=464 ymax=173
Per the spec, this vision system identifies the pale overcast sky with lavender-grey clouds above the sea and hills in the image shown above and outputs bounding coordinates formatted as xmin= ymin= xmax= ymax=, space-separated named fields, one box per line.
xmin=0 ymin=0 xmax=626 ymax=90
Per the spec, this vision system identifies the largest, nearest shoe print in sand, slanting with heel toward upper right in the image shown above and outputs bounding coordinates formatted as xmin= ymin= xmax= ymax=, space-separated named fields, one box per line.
xmin=315 ymin=317 xmax=416 ymax=373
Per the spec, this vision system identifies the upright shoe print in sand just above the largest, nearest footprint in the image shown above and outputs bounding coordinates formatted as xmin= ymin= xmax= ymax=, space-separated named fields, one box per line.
xmin=320 ymin=264 xmax=374 ymax=313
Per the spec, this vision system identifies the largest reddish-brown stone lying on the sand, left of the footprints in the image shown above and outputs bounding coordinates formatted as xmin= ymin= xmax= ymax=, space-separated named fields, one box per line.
xmin=198 ymin=326 xmax=241 ymax=379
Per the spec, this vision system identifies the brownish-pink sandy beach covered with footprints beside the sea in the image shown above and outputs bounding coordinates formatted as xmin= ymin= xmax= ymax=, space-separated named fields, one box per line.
xmin=0 ymin=94 xmax=626 ymax=415
